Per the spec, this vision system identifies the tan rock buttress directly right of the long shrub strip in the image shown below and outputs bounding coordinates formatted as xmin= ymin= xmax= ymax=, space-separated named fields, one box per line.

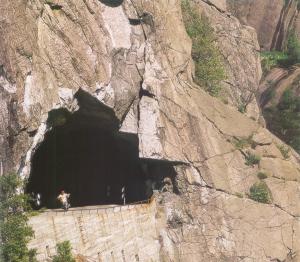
xmin=193 ymin=1 xmax=261 ymax=120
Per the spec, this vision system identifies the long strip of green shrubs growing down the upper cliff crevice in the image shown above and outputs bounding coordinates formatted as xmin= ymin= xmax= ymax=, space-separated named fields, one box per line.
xmin=181 ymin=0 xmax=226 ymax=96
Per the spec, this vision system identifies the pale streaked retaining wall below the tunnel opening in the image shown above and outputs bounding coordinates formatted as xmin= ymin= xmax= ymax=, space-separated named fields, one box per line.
xmin=29 ymin=201 xmax=160 ymax=262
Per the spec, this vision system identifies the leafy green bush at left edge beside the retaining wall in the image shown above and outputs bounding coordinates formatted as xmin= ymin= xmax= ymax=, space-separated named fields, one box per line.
xmin=0 ymin=174 xmax=36 ymax=262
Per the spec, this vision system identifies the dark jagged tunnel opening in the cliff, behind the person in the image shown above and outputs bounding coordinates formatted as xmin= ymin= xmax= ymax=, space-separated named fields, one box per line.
xmin=26 ymin=90 xmax=176 ymax=208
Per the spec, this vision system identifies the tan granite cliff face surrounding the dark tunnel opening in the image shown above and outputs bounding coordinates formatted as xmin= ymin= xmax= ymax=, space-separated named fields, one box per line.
xmin=0 ymin=0 xmax=300 ymax=261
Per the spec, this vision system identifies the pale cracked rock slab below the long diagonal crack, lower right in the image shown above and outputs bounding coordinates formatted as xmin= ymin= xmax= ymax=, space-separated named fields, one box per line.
xmin=159 ymin=187 xmax=300 ymax=262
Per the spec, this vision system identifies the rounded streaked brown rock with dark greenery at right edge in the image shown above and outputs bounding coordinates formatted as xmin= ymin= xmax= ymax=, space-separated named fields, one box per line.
xmin=258 ymin=65 xmax=300 ymax=156
